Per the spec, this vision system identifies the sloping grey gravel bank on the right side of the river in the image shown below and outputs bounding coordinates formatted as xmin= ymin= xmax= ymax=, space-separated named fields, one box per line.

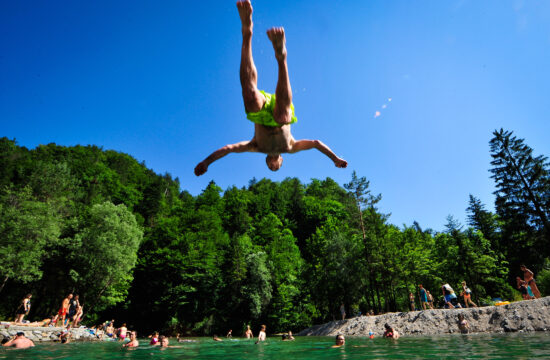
xmin=297 ymin=296 xmax=550 ymax=336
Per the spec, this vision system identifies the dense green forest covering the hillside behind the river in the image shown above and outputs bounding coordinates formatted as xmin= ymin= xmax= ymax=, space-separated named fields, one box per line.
xmin=0 ymin=130 xmax=550 ymax=335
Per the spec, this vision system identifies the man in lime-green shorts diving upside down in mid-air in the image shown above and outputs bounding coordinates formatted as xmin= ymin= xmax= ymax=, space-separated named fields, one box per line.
xmin=195 ymin=0 xmax=348 ymax=176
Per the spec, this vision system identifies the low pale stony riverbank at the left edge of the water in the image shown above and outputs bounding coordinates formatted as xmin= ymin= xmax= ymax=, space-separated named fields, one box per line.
xmin=0 ymin=325 xmax=100 ymax=342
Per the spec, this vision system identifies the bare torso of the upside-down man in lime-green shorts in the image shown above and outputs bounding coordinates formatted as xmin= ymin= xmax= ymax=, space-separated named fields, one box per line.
xmin=251 ymin=124 xmax=295 ymax=155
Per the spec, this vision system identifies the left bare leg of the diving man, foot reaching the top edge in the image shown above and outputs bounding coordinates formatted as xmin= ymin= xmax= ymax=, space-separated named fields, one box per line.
xmin=237 ymin=0 xmax=265 ymax=112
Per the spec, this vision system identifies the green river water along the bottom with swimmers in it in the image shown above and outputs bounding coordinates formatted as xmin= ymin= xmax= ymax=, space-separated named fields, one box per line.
xmin=0 ymin=333 xmax=550 ymax=360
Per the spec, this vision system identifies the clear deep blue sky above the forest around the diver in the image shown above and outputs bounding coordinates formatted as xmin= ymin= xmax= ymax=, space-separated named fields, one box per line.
xmin=0 ymin=0 xmax=550 ymax=230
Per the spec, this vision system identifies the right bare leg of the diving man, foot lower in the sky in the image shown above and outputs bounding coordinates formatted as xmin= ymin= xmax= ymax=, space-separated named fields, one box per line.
xmin=267 ymin=27 xmax=292 ymax=125
